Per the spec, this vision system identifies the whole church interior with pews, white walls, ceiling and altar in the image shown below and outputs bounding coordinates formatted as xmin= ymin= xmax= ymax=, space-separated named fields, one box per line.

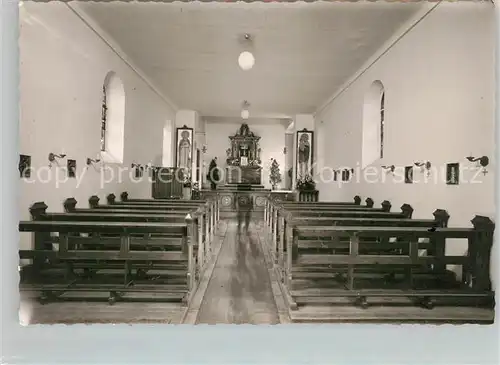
xmin=18 ymin=1 xmax=500 ymax=324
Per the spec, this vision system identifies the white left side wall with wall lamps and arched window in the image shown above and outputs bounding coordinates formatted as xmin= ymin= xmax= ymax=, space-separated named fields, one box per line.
xmin=19 ymin=2 xmax=175 ymax=248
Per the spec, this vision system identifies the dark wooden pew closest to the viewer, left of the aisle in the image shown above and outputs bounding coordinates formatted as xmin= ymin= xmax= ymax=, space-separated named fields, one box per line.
xmin=19 ymin=217 xmax=197 ymax=304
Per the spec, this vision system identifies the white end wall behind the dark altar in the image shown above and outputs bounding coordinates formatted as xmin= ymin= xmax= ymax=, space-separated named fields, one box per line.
xmin=203 ymin=118 xmax=286 ymax=189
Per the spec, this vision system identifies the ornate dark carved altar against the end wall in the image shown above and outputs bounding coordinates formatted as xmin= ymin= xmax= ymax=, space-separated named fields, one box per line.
xmin=226 ymin=123 xmax=262 ymax=185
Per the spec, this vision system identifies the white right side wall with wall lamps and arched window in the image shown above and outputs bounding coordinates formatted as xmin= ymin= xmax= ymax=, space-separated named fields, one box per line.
xmin=316 ymin=2 xmax=498 ymax=284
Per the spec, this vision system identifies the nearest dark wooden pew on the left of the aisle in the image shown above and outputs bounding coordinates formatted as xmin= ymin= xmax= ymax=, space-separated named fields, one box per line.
xmin=19 ymin=218 xmax=196 ymax=304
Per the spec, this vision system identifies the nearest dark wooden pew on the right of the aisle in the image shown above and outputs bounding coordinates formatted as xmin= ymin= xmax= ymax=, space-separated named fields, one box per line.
xmin=285 ymin=216 xmax=494 ymax=321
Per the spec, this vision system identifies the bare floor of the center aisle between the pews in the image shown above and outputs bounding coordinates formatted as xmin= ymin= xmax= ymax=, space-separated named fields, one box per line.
xmin=196 ymin=220 xmax=280 ymax=324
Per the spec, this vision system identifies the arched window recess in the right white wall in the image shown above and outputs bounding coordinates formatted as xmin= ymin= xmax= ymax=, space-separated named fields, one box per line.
xmin=362 ymin=80 xmax=385 ymax=168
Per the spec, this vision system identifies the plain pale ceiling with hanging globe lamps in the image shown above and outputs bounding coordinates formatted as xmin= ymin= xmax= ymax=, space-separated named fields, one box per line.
xmin=78 ymin=1 xmax=422 ymax=117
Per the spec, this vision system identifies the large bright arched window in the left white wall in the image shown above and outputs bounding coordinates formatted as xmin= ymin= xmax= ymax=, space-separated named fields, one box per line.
xmin=101 ymin=72 xmax=125 ymax=163
